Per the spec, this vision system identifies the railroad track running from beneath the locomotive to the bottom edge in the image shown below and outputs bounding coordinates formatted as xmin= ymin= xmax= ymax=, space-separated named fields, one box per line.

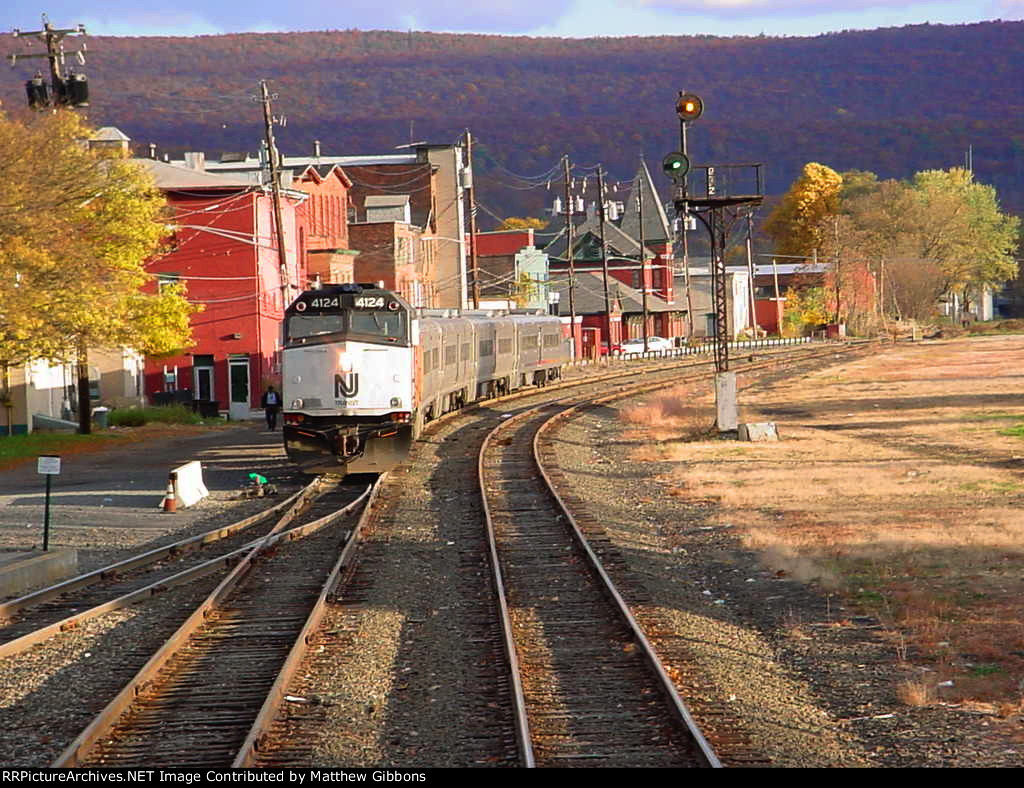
xmin=54 ymin=474 xmax=380 ymax=768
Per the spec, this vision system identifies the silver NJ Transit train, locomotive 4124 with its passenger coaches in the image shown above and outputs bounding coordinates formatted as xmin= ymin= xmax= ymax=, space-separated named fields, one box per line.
xmin=282 ymin=283 xmax=571 ymax=474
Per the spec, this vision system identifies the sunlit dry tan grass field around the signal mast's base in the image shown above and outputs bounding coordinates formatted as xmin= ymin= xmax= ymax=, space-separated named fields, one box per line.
xmin=623 ymin=337 xmax=1024 ymax=705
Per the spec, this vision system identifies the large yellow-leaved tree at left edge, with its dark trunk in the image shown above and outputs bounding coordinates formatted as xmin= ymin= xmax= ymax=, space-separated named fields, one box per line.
xmin=0 ymin=111 xmax=195 ymax=433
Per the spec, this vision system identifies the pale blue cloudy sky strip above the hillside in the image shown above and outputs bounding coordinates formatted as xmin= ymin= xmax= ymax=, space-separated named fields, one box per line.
xmin=0 ymin=0 xmax=1024 ymax=39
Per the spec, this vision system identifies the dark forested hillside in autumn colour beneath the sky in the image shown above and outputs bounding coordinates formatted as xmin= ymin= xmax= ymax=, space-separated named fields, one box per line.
xmin=0 ymin=21 xmax=1024 ymax=215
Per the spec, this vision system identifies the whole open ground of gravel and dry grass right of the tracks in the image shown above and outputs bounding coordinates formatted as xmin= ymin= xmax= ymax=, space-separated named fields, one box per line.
xmin=560 ymin=336 xmax=1024 ymax=765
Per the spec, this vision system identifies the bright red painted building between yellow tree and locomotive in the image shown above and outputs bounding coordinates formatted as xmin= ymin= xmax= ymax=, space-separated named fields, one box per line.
xmin=138 ymin=155 xmax=305 ymax=419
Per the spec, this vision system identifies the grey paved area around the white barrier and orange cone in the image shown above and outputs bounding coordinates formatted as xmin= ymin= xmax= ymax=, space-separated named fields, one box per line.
xmin=0 ymin=425 xmax=296 ymax=549
